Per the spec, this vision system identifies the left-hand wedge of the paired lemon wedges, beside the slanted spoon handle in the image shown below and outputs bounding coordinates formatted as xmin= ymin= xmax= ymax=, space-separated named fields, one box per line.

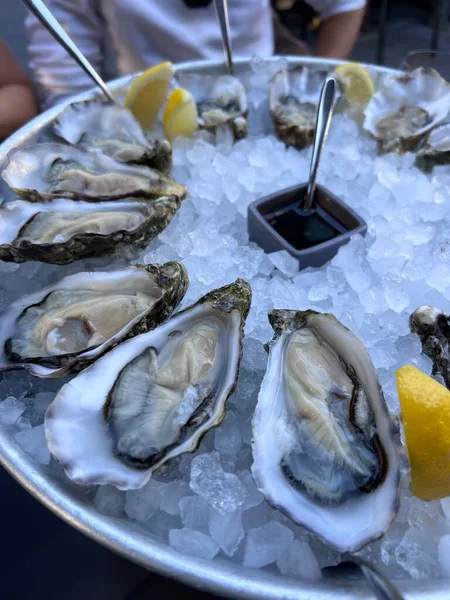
xmin=125 ymin=62 xmax=175 ymax=129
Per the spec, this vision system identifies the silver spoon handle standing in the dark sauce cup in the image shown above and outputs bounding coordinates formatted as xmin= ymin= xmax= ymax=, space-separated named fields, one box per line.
xmin=303 ymin=77 xmax=336 ymax=211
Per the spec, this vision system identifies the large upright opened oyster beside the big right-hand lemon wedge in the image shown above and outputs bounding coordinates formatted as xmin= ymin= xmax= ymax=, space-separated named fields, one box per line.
xmin=252 ymin=310 xmax=399 ymax=552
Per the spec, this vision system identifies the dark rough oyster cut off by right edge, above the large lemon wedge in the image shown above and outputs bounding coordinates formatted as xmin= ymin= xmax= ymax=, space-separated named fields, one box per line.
xmin=409 ymin=306 xmax=450 ymax=389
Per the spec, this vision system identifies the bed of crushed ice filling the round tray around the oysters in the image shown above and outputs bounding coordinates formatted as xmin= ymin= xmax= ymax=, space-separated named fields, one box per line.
xmin=0 ymin=62 xmax=450 ymax=579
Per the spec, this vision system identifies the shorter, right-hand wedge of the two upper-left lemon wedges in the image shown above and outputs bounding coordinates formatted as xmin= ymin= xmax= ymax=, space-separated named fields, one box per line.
xmin=164 ymin=88 xmax=198 ymax=141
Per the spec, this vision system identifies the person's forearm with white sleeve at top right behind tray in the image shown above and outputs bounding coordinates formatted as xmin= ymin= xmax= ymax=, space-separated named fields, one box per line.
xmin=307 ymin=0 xmax=365 ymax=58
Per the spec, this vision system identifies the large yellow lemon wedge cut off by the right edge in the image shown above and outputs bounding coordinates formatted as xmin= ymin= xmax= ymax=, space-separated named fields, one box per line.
xmin=396 ymin=365 xmax=450 ymax=500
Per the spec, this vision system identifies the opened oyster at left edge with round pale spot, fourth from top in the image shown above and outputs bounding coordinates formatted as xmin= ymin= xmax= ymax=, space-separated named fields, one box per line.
xmin=0 ymin=262 xmax=189 ymax=377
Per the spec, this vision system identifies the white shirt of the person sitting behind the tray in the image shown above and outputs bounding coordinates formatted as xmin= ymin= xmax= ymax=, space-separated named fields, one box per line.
xmin=26 ymin=0 xmax=365 ymax=107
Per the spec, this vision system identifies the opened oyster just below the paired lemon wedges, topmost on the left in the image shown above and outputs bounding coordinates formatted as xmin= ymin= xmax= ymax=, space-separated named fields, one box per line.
xmin=54 ymin=100 xmax=172 ymax=173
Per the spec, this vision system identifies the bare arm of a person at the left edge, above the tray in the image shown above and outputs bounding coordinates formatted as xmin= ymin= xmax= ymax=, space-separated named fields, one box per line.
xmin=0 ymin=40 xmax=38 ymax=141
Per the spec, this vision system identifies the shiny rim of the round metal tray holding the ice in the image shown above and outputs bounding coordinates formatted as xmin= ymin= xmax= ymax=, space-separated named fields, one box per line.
xmin=0 ymin=57 xmax=450 ymax=600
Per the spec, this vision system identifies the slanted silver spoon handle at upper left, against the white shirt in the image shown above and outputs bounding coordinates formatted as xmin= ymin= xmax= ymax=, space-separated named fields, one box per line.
xmin=23 ymin=0 xmax=114 ymax=102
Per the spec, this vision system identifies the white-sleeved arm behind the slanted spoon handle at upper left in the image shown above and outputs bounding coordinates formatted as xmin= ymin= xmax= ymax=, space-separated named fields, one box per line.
xmin=25 ymin=0 xmax=104 ymax=108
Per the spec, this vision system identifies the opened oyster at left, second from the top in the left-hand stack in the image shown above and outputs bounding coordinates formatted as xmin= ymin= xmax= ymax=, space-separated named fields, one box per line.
xmin=2 ymin=143 xmax=187 ymax=202
